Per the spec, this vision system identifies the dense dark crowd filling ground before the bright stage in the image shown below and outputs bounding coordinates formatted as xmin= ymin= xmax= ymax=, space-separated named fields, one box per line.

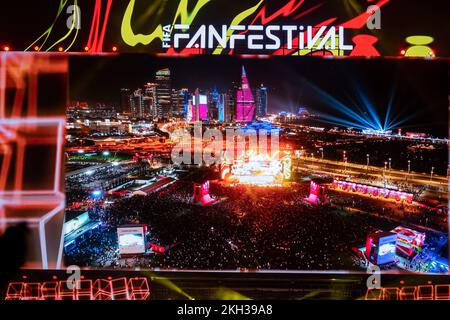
xmin=66 ymin=181 xmax=446 ymax=270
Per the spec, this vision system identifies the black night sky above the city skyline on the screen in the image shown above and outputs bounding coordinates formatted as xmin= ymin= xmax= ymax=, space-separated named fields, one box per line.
xmin=69 ymin=54 xmax=449 ymax=137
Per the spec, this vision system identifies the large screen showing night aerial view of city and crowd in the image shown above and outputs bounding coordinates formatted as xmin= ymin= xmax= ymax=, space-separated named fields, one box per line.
xmin=64 ymin=55 xmax=449 ymax=273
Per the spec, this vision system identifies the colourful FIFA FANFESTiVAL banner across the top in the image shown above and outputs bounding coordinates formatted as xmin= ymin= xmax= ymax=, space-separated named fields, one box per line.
xmin=0 ymin=0 xmax=450 ymax=57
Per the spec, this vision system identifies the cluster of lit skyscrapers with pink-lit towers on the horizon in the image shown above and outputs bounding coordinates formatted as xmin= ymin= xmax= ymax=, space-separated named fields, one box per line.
xmin=68 ymin=60 xmax=268 ymax=122
